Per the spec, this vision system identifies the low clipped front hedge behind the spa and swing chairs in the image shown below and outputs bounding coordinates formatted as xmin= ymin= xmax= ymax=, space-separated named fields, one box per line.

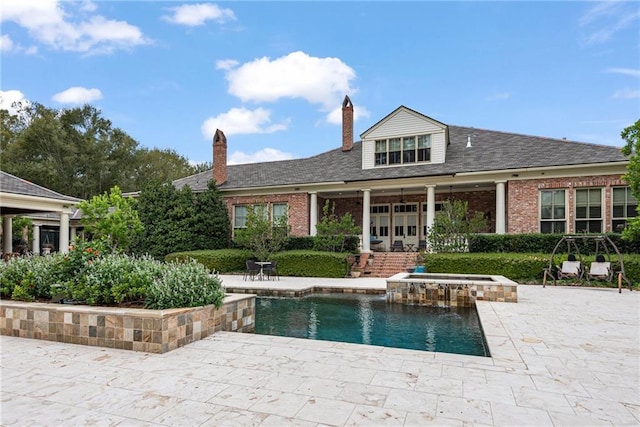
xmin=425 ymin=253 xmax=640 ymax=287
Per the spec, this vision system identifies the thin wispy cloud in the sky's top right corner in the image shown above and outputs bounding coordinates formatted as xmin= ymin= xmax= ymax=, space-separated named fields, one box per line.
xmin=578 ymin=1 xmax=640 ymax=44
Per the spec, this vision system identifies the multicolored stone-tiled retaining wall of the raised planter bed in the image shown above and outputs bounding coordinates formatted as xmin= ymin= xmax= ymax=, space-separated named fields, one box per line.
xmin=0 ymin=295 xmax=255 ymax=353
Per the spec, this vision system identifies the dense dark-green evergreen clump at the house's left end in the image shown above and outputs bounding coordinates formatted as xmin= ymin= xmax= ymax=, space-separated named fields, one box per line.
xmin=132 ymin=181 xmax=230 ymax=258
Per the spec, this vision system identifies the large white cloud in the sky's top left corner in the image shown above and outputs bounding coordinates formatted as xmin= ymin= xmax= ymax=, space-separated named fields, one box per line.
xmin=1 ymin=0 xmax=151 ymax=54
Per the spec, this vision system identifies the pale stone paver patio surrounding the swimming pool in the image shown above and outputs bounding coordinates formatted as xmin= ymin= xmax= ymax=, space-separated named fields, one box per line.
xmin=0 ymin=276 xmax=640 ymax=426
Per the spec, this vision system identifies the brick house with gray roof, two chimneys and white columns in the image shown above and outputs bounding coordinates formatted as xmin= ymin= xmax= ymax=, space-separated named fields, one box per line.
xmin=174 ymin=96 xmax=637 ymax=252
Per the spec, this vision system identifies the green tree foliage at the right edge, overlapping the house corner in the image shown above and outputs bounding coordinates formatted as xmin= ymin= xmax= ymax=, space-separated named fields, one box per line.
xmin=620 ymin=120 xmax=640 ymax=241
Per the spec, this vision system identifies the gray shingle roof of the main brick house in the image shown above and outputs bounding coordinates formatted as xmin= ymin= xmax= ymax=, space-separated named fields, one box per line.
xmin=174 ymin=126 xmax=628 ymax=190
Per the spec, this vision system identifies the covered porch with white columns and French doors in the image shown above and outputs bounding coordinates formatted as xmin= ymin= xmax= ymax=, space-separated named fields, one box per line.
xmin=309 ymin=180 xmax=507 ymax=253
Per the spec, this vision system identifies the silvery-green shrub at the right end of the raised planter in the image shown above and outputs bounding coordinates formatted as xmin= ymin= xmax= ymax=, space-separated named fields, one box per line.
xmin=145 ymin=260 xmax=224 ymax=309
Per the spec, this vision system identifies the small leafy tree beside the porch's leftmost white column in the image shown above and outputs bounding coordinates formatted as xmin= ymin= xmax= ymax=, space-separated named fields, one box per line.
xmin=313 ymin=200 xmax=361 ymax=252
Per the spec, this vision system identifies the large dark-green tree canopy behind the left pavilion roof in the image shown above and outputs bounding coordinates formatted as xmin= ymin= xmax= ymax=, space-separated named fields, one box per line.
xmin=0 ymin=103 xmax=207 ymax=199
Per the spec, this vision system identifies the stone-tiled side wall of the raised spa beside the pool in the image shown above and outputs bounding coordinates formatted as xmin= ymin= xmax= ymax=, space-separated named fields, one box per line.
xmin=387 ymin=281 xmax=518 ymax=307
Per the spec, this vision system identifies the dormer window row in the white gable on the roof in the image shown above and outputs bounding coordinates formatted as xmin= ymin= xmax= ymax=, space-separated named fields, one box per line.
xmin=375 ymin=135 xmax=431 ymax=166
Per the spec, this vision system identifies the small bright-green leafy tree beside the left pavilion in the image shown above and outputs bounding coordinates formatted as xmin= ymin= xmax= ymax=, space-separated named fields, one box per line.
xmin=78 ymin=186 xmax=144 ymax=252
